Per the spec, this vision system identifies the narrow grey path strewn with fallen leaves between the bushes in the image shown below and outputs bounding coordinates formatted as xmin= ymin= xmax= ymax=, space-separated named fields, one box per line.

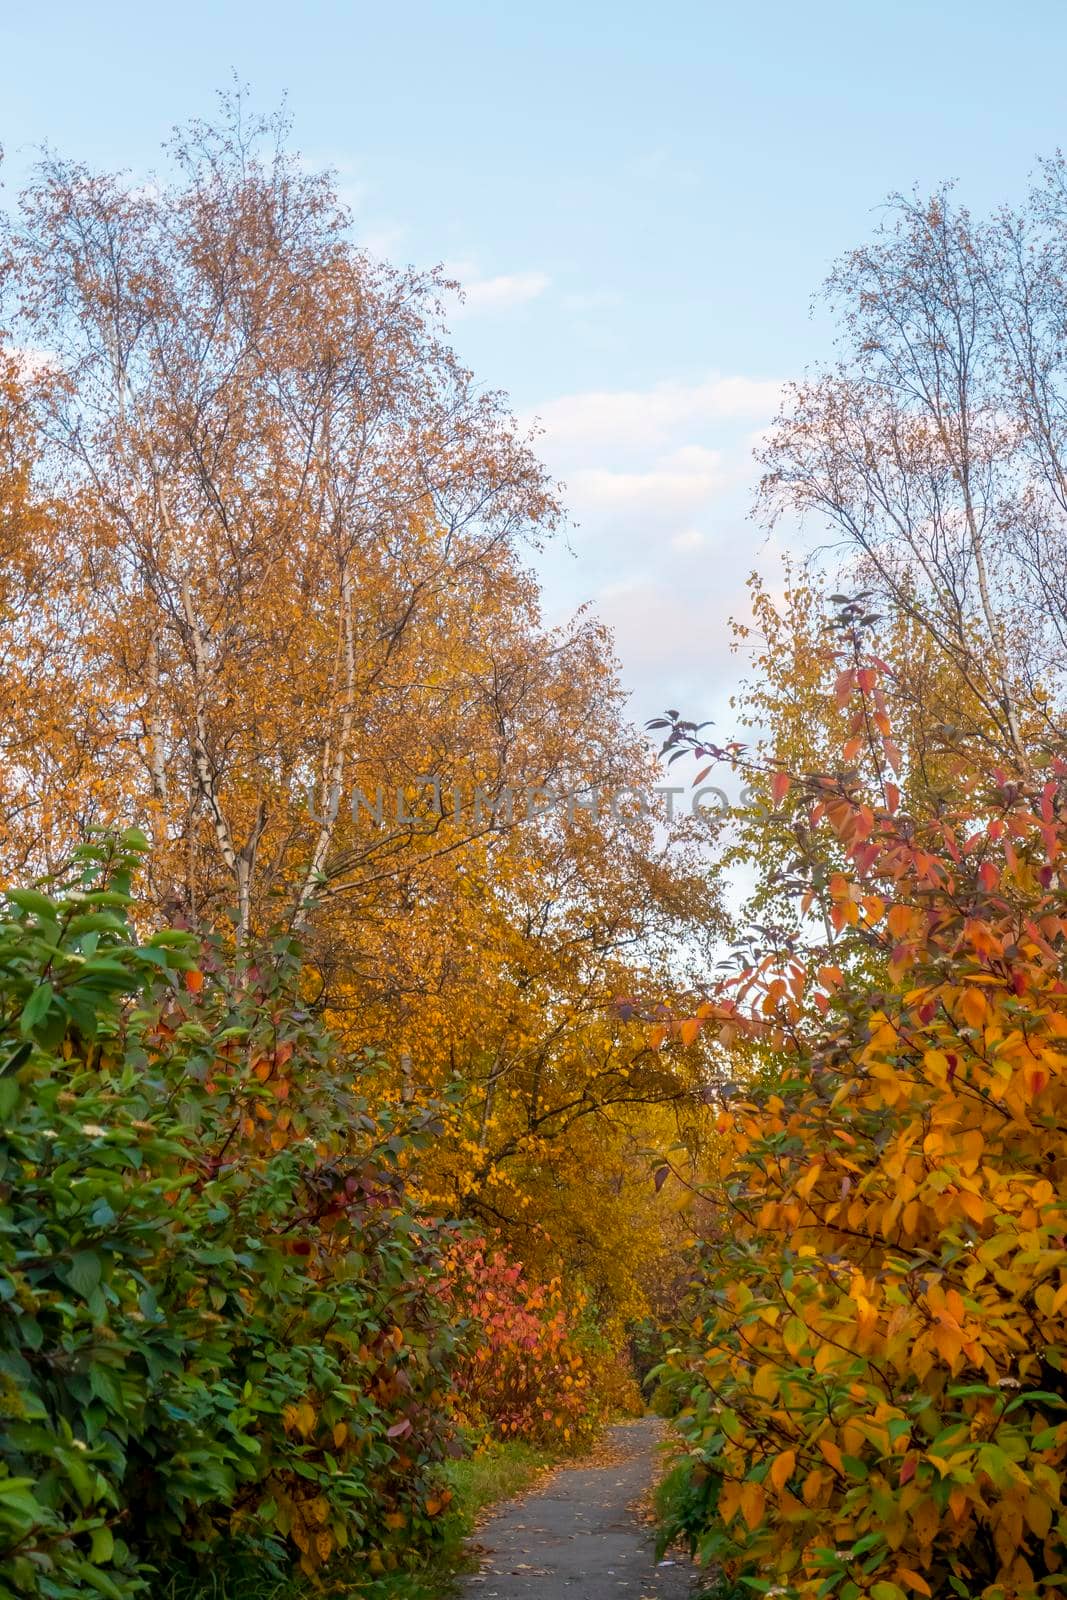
xmin=462 ymin=1418 xmax=691 ymax=1600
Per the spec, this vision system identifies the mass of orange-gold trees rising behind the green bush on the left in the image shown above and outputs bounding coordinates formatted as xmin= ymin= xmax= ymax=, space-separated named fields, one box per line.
xmin=0 ymin=101 xmax=715 ymax=1337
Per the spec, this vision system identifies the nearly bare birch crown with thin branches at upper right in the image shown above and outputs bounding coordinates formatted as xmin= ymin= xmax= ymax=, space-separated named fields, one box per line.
xmin=763 ymin=157 xmax=1067 ymax=773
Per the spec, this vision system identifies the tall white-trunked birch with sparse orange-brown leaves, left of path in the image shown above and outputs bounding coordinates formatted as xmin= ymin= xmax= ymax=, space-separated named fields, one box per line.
xmin=6 ymin=106 xmax=566 ymax=934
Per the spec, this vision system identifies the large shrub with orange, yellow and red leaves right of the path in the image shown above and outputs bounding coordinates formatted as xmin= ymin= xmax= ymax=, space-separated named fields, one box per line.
xmin=667 ymin=674 xmax=1067 ymax=1600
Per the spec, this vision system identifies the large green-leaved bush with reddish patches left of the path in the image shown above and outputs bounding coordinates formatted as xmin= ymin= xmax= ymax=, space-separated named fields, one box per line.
xmin=0 ymin=835 xmax=456 ymax=1600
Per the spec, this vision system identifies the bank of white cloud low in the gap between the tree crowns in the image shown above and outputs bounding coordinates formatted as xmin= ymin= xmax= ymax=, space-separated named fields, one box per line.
xmin=528 ymin=373 xmax=781 ymax=722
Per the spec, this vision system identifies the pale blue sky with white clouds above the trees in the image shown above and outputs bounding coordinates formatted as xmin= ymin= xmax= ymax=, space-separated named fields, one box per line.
xmin=0 ymin=0 xmax=1067 ymax=718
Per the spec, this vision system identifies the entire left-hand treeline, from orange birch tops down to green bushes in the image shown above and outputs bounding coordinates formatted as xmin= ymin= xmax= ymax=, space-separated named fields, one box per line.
xmin=0 ymin=102 xmax=717 ymax=1600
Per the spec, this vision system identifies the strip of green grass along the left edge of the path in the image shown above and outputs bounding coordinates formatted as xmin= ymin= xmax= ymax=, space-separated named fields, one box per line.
xmin=154 ymin=1443 xmax=555 ymax=1600
